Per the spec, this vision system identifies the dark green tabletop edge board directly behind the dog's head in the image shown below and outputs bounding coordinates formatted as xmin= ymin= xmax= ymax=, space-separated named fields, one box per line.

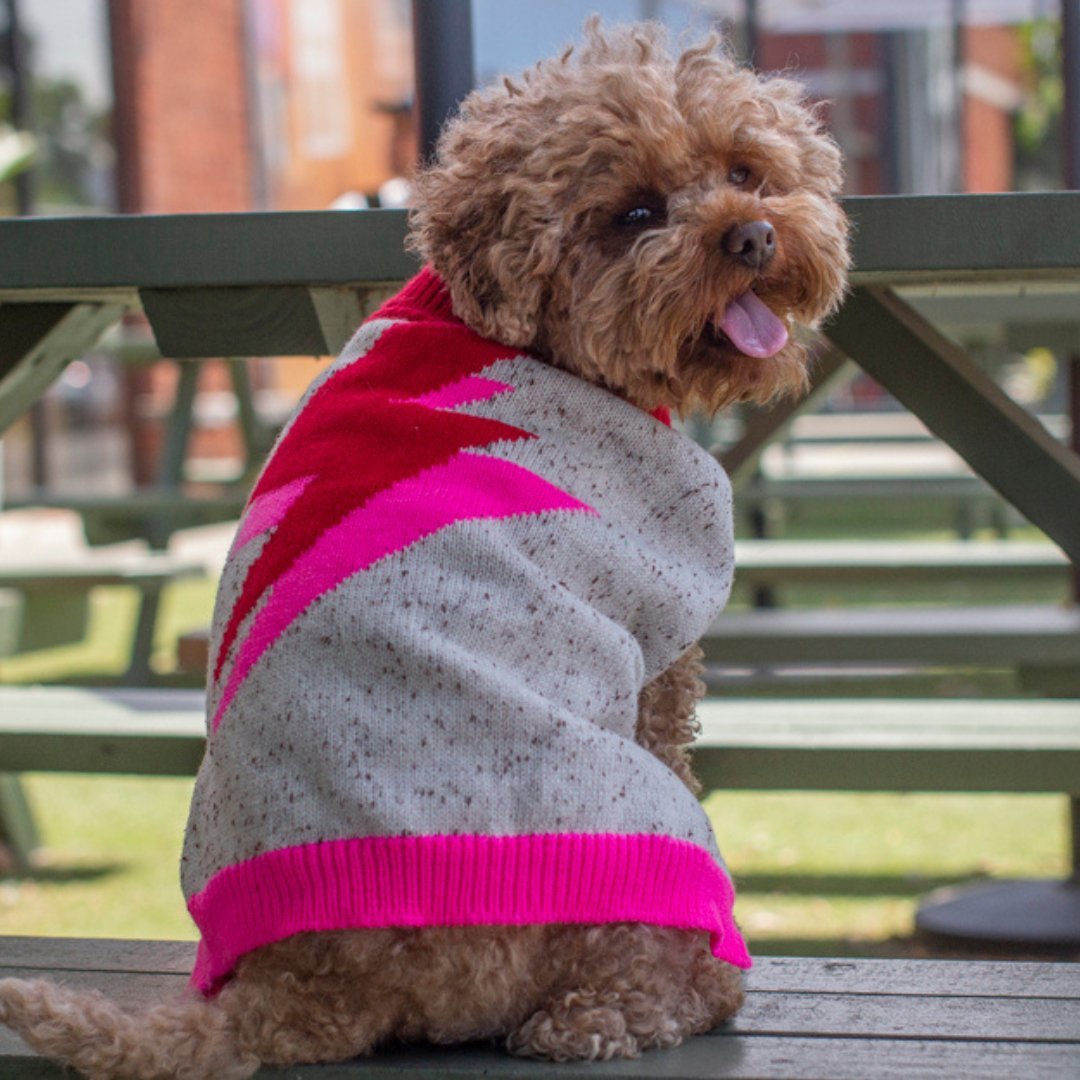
xmin=0 ymin=192 xmax=1080 ymax=298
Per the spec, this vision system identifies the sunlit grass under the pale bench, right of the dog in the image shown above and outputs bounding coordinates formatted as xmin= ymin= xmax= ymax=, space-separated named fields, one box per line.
xmin=705 ymin=792 xmax=1068 ymax=955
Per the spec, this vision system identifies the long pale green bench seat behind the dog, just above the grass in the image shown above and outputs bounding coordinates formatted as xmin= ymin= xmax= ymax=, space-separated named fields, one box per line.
xmin=0 ymin=687 xmax=1080 ymax=795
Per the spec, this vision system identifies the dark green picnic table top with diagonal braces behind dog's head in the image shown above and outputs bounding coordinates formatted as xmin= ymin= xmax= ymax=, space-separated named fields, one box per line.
xmin=0 ymin=192 xmax=1080 ymax=946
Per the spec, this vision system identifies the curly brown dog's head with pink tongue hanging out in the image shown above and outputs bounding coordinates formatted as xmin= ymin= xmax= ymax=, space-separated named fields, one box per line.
xmin=413 ymin=23 xmax=848 ymax=411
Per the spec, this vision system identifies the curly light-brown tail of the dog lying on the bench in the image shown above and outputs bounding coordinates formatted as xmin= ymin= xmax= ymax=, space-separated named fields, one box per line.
xmin=0 ymin=978 xmax=259 ymax=1080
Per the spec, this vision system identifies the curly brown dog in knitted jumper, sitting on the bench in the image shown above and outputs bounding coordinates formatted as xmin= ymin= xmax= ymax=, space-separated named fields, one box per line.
xmin=0 ymin=21 xmax=848 ymax=1078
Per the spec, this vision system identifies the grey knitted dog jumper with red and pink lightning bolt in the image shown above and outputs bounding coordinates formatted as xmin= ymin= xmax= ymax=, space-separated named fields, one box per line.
xmin=181 ymin=265 xmax=750 ymax=993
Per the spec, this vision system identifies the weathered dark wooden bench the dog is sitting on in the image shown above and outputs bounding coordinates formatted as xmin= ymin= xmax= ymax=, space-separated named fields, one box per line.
xmin=0 ymin=937 xmax=1080 ymax=1080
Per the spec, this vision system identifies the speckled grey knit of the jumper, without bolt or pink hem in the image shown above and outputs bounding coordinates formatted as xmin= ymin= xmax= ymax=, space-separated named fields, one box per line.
xmin=183 ymin=272 xmax=751 ymax=989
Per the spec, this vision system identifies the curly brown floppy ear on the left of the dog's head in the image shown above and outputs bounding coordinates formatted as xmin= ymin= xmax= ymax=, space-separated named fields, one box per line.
xmin=408 ymin=95 xmax=559 ymax=348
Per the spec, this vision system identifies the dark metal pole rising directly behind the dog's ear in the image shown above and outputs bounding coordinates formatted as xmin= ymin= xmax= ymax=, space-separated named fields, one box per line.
xmin=413 ymin=0 xmax=474 ymax=161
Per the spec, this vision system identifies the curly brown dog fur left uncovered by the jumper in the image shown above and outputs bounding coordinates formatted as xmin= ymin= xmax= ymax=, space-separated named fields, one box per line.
xmin=0 ymin=22 xmax=848 ymax=1080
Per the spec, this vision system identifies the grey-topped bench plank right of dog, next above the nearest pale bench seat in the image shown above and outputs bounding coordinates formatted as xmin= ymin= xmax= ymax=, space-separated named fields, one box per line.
xmin=702 ymin=605 xmax=1080 ymax=667
